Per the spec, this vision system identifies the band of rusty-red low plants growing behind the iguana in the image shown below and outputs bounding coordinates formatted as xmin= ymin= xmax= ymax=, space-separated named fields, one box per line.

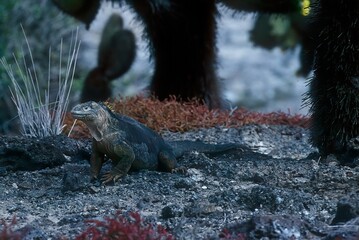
xmin=65 ymin=96 xmax=308 ymax=138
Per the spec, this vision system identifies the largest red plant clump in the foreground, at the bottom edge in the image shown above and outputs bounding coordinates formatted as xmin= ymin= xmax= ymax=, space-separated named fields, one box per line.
xmin=76 ymin=212 xmax=174 ymax=240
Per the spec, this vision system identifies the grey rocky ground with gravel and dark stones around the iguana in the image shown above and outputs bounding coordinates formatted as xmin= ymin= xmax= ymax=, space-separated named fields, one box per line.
xmin=0 ymin=125 xmax=359 ymax=239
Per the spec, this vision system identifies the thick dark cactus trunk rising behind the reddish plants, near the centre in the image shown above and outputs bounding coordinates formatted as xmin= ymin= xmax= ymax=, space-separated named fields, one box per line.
xmin=129 ymin=0 xmax=220 ymax=108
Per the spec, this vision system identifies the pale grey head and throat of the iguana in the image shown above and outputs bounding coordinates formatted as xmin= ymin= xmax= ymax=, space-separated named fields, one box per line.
xmin=71 ymin=101 xmax=110 ymax=141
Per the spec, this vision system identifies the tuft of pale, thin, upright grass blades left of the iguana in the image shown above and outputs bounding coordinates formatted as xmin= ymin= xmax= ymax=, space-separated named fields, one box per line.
xmin=0 ymin=27 xmax=80 ymax=137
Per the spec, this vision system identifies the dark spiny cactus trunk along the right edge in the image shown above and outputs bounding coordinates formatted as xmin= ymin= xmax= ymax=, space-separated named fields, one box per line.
xmin=309 ymin=0 xmax=359 ymax=155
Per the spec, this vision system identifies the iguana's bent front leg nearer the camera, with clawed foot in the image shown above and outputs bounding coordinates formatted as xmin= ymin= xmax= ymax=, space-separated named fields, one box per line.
xmin=101 ymin=143 xmax=135 ymax=184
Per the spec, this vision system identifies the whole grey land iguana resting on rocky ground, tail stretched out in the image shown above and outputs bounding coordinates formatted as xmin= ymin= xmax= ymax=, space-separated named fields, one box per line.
xmin=71 ymin=101 xmax=243 ymax=183
